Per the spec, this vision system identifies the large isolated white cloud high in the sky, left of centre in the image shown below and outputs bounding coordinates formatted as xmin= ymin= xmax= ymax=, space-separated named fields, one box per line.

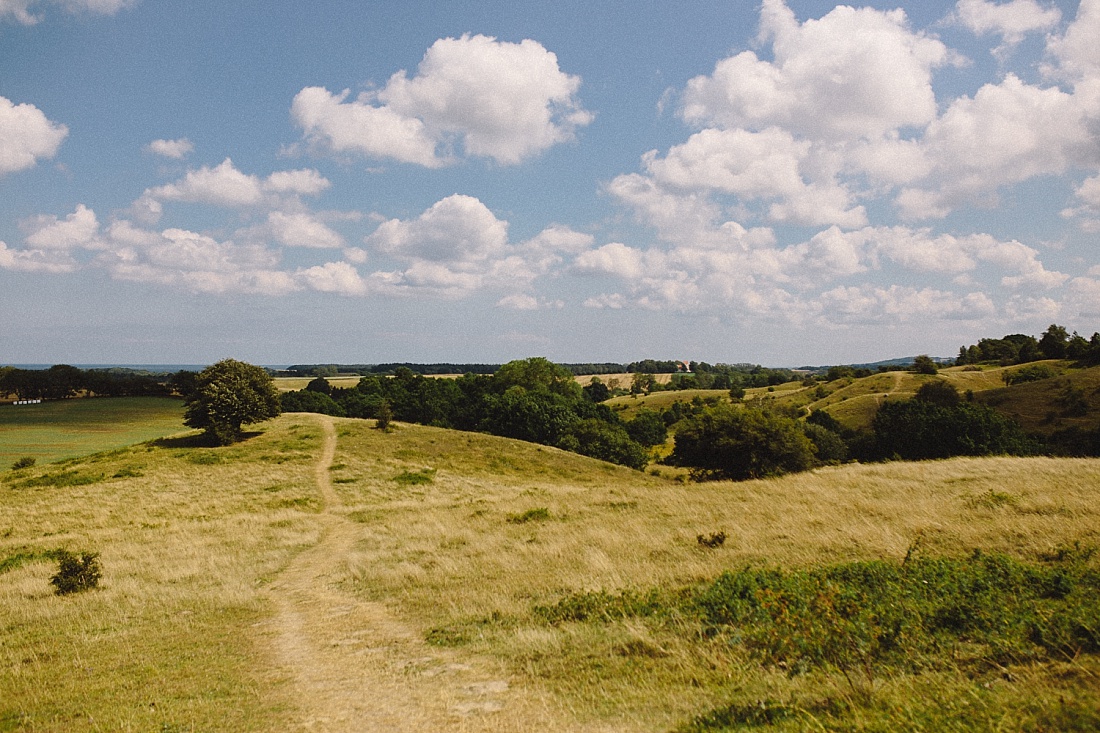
xmin=290 ymin=35 xmax=592 ymax=167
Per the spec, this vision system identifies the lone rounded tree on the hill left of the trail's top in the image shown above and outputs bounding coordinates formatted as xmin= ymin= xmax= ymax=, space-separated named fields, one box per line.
xmin=184 ymin=359 xmax=281 ymax=446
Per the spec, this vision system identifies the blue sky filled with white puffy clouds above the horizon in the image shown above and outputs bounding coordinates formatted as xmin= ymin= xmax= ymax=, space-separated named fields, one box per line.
xmin=0 ymin=0 xmax=1100 ymax=367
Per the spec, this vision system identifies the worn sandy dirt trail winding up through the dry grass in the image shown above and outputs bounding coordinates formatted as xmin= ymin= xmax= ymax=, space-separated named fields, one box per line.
xmin=270 ymin=416 xmax=541 ymax=733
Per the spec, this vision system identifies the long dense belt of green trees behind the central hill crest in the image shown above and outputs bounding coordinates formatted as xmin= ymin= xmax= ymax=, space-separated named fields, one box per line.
xmin=282 ymin=357 xmax=664 ymax=469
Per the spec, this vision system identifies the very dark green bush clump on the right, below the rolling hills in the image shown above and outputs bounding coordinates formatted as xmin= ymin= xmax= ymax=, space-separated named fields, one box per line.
xmin=868 ymin=400 xmax=1034 ymax=460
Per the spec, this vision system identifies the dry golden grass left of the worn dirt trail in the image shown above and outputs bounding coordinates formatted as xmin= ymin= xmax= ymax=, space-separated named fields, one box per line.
xmin=0 ymin=419 xmax=319 ymax=731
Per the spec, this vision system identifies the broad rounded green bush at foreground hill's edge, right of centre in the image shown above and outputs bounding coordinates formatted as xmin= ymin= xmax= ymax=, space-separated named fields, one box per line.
xmin=668 ymin=405 xmax=814 ymax=481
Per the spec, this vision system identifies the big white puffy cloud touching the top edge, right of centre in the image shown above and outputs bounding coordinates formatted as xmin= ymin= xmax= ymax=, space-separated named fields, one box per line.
xmin=682 ymin=0 xmax=950 ymax=139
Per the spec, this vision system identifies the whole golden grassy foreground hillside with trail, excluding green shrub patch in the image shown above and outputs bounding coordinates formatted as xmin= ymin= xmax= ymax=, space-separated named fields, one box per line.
xmin=0 ymin=415 xmax=1100 ymax=731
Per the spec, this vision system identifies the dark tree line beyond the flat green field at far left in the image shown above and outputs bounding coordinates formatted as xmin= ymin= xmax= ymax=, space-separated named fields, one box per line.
xmin=0 ymin=364 xmax=184 ymax=400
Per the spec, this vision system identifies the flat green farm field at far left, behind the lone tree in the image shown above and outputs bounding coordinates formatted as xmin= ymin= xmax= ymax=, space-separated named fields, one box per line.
xmin=0 ymin=397 xmax=187 ymax=470
